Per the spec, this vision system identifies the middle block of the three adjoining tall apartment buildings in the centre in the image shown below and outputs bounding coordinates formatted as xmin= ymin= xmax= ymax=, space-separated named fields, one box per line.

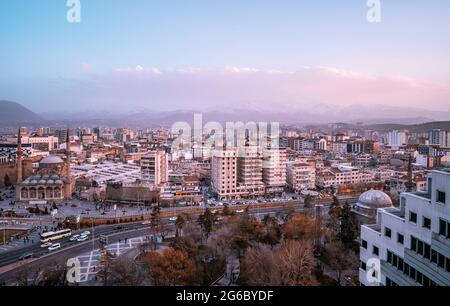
xmin=237 ymin=146 xmax=264 ymax=196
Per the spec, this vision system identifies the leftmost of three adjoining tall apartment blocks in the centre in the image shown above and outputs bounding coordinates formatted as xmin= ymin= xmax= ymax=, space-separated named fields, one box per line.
xmin=211 ymin=149 xmax=240 ymax=200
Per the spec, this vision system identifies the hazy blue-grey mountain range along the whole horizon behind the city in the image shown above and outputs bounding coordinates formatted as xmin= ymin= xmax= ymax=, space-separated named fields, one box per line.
xmin=0 ymin=101 xmax=450 ymax=130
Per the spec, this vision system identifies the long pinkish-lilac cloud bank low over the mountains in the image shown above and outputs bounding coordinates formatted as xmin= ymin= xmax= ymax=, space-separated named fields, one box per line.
xmin=22 ymin=65 xmax=450 ymax=111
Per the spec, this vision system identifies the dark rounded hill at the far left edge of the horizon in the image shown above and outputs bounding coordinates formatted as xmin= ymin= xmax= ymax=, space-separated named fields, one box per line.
xmin=0 ymin=100 xmax=43 ymax=126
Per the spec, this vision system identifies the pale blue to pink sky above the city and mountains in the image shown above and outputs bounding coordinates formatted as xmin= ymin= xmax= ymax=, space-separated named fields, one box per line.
xmin=0 ymin=0 xmax=450 ymax=112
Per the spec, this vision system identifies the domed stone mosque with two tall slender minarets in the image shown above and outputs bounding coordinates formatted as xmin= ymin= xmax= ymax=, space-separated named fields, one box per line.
xmin=16 ymin=131 xmax=74 ymax=203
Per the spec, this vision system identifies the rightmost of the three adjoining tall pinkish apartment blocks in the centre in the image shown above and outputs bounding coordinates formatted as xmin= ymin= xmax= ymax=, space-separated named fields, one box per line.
xmin=263 ymin=147 xmax=287 ymax=194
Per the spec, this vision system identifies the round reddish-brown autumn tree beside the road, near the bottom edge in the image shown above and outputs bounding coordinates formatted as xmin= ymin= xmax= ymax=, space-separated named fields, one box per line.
xmin=142 ymin=248 xmax=196 ymax=286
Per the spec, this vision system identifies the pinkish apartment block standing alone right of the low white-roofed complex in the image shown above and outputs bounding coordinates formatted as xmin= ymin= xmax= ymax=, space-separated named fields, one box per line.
xmin=141 ymin=150 xmax=169 ymax=186
